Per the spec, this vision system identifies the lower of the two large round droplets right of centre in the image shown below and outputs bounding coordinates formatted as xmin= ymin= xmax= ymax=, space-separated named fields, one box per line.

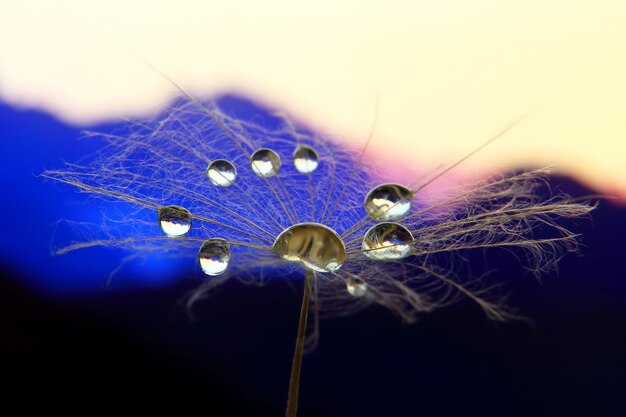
xmin=362 ymin=222 xmax=413 ymax=261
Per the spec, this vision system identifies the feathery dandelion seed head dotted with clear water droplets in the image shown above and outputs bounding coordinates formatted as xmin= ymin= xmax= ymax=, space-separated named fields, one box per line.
xmin=44 ymin=97 xmax=593 ymax=322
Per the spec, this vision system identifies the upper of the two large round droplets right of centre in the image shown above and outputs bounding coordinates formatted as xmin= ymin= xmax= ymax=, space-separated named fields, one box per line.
xmin=365 ymin=184 xmax=413 ymax=221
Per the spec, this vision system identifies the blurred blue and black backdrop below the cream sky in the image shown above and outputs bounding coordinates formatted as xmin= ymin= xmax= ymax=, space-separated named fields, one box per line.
xmin=0 ymin=98 xmax=626 ymax=416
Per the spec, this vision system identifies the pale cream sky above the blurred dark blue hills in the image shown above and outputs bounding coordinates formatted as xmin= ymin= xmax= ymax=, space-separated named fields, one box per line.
xmin=0 ymin=0 xmax=626 ymax=199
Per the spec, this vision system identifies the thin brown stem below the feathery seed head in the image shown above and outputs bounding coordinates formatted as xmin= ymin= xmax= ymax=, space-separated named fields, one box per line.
xmin=285 ymin=268 xmax=315 ymax=417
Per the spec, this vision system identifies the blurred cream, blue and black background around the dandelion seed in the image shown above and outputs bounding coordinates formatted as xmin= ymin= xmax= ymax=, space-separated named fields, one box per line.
xmin=0 ymin=0 xmax=626 ymax=416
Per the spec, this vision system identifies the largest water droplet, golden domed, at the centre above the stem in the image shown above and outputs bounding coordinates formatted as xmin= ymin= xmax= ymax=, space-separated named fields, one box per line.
xmin=273 ymin=223 xmax=346 ymax=272
